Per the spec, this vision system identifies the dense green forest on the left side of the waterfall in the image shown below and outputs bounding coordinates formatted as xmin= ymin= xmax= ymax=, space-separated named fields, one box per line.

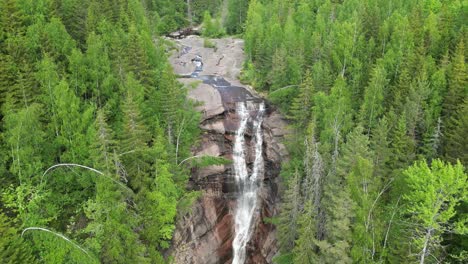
xmin=0 ymin=0 xmax=208 ymax=263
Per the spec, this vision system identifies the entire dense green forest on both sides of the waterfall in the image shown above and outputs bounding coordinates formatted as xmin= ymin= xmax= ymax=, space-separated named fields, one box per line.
xmin=0 ymin=0 xmax=468 ymax=264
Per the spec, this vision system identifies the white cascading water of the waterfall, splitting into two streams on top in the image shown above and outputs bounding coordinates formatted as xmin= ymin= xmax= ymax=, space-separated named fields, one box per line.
xmin=232 ymin=103 xmax=265 ymax=264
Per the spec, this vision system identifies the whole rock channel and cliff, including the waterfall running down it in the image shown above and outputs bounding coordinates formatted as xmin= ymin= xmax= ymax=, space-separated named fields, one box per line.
xmin=166 ymin=36 xmax=287 ymax=264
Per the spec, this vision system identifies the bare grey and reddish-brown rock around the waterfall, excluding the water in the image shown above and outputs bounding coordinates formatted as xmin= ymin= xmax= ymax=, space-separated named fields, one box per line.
xmin=166 ymin=37 xmax=287 ymax=264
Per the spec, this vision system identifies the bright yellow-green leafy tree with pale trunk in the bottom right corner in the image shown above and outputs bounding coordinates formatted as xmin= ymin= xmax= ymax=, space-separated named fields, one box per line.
xmin=403 ymin=160 xmax=468 ymax=263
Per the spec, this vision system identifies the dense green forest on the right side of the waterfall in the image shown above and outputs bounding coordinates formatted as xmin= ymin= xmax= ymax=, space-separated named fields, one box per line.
xmin=239 ymin=0 xmax=468 ymax=263
